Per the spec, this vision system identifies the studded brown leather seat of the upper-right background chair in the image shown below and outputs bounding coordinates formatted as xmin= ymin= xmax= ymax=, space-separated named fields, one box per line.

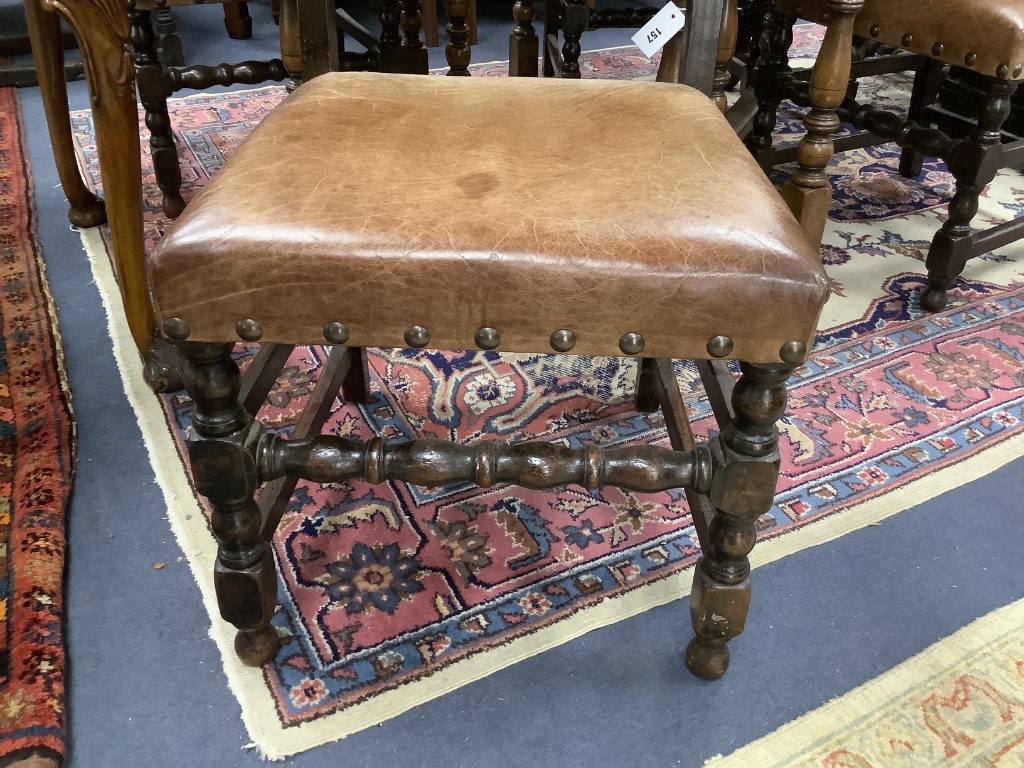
xmin=775 ymin=0 xmax=1024 ymax=80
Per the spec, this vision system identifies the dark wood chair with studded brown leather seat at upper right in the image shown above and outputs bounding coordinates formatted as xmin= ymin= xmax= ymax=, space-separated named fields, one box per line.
xmin=748 ymin=0 xmax=1024 ymax=311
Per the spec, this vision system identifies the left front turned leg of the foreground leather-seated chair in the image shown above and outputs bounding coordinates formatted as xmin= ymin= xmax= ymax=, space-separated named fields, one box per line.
xmin=178 ymin=342 xmax=281 ymax=667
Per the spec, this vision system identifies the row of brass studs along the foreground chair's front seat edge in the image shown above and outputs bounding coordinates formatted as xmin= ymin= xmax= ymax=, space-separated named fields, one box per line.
xmin=164 ymin=317 xmax=807 ymax=366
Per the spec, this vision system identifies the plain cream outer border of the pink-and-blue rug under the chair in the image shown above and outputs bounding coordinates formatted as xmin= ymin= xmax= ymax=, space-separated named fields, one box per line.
xmin=81 ymin=228 xmax=1024 ymax=760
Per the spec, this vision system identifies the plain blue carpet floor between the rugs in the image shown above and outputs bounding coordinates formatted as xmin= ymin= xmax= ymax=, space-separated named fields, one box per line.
xmin=9 ymin=3 xmax=1024 ymax=768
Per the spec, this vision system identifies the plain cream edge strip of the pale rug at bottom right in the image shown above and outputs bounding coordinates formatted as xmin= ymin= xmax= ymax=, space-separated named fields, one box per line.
xmin=705 ymin=600 xmax=1024 ymax=768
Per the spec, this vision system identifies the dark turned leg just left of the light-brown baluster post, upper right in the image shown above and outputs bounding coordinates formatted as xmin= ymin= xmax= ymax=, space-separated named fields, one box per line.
xmin=745 ymin=10 xmax=797 ymax=165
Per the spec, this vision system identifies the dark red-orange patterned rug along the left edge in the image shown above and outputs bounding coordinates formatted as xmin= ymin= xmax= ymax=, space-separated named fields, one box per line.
xmin=0 ymin=88 xmax=75 ymax=765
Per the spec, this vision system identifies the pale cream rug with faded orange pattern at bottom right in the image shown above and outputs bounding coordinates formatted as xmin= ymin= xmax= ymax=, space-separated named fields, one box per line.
xmin=705 ymin=600 xmax=1024 ymax=768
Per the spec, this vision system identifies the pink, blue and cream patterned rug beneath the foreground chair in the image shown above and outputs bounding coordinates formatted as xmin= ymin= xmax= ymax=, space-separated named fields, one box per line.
xmin=74 ymin=36 xmax=1024 ymax=757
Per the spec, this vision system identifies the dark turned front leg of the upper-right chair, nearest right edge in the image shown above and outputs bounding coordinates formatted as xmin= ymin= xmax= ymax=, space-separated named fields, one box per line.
xmin=921 ymin=78 xmax=1018 ymax=312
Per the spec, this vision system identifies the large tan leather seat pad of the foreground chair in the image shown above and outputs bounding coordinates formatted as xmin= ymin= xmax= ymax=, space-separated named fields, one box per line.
xmin=150 ymin=74 xmax=827 ymax=362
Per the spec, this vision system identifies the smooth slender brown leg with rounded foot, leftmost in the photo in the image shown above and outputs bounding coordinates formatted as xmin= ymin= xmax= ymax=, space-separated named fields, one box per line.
xmin=25 ymin=0 xmax=106 ymax=227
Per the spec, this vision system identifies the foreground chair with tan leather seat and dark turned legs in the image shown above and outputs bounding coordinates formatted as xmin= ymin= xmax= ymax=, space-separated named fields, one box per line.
xmin=148 ymin=74 xmax=828 ymax=679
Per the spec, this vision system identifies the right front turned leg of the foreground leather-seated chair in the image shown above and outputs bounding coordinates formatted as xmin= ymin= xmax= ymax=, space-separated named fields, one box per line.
xmin=686 ymin=362 xmax=792 ymax=680
